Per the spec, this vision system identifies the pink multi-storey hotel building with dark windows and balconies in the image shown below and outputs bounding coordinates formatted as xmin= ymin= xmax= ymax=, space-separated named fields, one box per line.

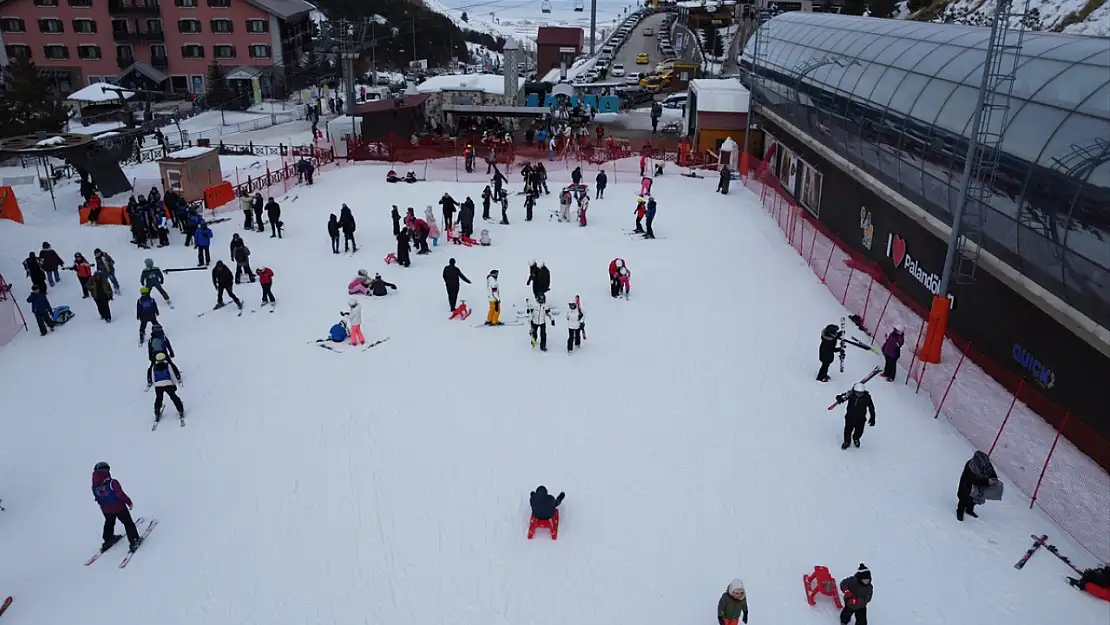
xmin=0 ymin=0 xmax=313 ymax=97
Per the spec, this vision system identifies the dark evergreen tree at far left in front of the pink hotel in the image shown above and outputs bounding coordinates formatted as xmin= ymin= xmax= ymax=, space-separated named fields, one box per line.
xmin=0 ymin=59 xmax=69 ymax=138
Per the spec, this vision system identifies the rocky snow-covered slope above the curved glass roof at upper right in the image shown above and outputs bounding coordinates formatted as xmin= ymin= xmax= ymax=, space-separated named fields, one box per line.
xmin=911 ymin=0 xmax=1110 ymax=37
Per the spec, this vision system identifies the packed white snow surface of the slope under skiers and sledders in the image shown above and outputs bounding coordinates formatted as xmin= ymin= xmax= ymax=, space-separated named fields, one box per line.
xmin=0 ymin=163 xmax=1110 ymax=625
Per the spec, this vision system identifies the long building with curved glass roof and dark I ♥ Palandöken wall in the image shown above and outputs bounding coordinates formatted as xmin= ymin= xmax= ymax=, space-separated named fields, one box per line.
xmin=741 ymin=12 xmax=1110 ymax=459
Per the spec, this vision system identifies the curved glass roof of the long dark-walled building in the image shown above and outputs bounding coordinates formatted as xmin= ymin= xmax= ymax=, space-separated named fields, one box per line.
xmin=741 ymin=12 xmax=1110 ymax=327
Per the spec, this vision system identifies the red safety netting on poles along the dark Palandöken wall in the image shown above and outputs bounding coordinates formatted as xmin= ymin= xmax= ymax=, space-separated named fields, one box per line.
xmin=744 ymin=159 xmax=1110 ymax=562
